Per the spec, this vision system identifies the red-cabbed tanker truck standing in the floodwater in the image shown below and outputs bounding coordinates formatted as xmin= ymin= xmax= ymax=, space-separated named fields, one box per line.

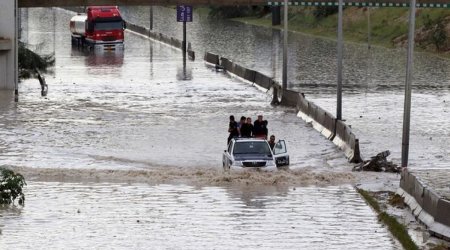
xmin=70 ymin=6 xmax=125 ymax=50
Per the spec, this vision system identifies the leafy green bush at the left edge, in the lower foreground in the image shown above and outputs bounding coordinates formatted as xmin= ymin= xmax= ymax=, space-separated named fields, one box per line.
xmin=0 ymin=167 xmax=27 ymax=206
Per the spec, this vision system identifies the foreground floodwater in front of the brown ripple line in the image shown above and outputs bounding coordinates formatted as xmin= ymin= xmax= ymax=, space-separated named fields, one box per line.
xmin=0 ymin=182 xmax=394 ymax=249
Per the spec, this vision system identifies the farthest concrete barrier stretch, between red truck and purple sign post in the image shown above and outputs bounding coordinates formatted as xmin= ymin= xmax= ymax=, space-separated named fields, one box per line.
xmin=127 ymin=22 xmax=195 ymax=60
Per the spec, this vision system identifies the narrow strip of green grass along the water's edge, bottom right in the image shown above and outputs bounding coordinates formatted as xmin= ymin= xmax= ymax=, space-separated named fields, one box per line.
xmin=356 ymin=188 xmax=419 ymax=250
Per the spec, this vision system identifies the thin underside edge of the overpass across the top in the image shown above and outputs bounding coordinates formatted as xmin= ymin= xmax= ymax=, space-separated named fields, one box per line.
xmin=18 ymin=0 xmax=450 ymax=8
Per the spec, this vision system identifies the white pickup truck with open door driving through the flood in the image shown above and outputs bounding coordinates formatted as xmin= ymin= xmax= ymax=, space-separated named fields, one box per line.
xmin=222 ymin=138 xmax=289 ymax=170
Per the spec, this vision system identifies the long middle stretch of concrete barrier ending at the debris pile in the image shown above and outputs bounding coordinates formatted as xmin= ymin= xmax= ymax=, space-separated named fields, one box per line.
xmin=204 ymin=52 xmax=362 ymax=162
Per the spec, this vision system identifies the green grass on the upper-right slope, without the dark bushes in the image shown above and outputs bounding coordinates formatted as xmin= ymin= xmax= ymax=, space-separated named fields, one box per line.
xmin=234 ymin=7 xmax=450 ymax=53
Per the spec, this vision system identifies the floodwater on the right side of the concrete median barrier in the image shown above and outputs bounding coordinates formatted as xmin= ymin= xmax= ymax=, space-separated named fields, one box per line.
xmin=119 ymin=7 xmax=450 ymax=169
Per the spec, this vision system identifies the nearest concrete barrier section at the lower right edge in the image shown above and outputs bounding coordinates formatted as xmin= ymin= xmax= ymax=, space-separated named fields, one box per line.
xmin=397 ymin=169 xmax=450 ymax=240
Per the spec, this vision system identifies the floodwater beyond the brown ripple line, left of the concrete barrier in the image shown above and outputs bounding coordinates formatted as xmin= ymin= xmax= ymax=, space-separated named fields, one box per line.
xmin=0 ymin=9 xmax=346 ymax=168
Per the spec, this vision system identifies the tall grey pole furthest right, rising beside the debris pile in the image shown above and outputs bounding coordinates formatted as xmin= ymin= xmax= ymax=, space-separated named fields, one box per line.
xmin=402 ymin=0 xmax=416 ymax=168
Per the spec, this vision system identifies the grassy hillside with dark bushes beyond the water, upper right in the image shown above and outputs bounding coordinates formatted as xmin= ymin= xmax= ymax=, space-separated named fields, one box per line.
xmin=233 ymin=7 xmax=450 ymax=56
